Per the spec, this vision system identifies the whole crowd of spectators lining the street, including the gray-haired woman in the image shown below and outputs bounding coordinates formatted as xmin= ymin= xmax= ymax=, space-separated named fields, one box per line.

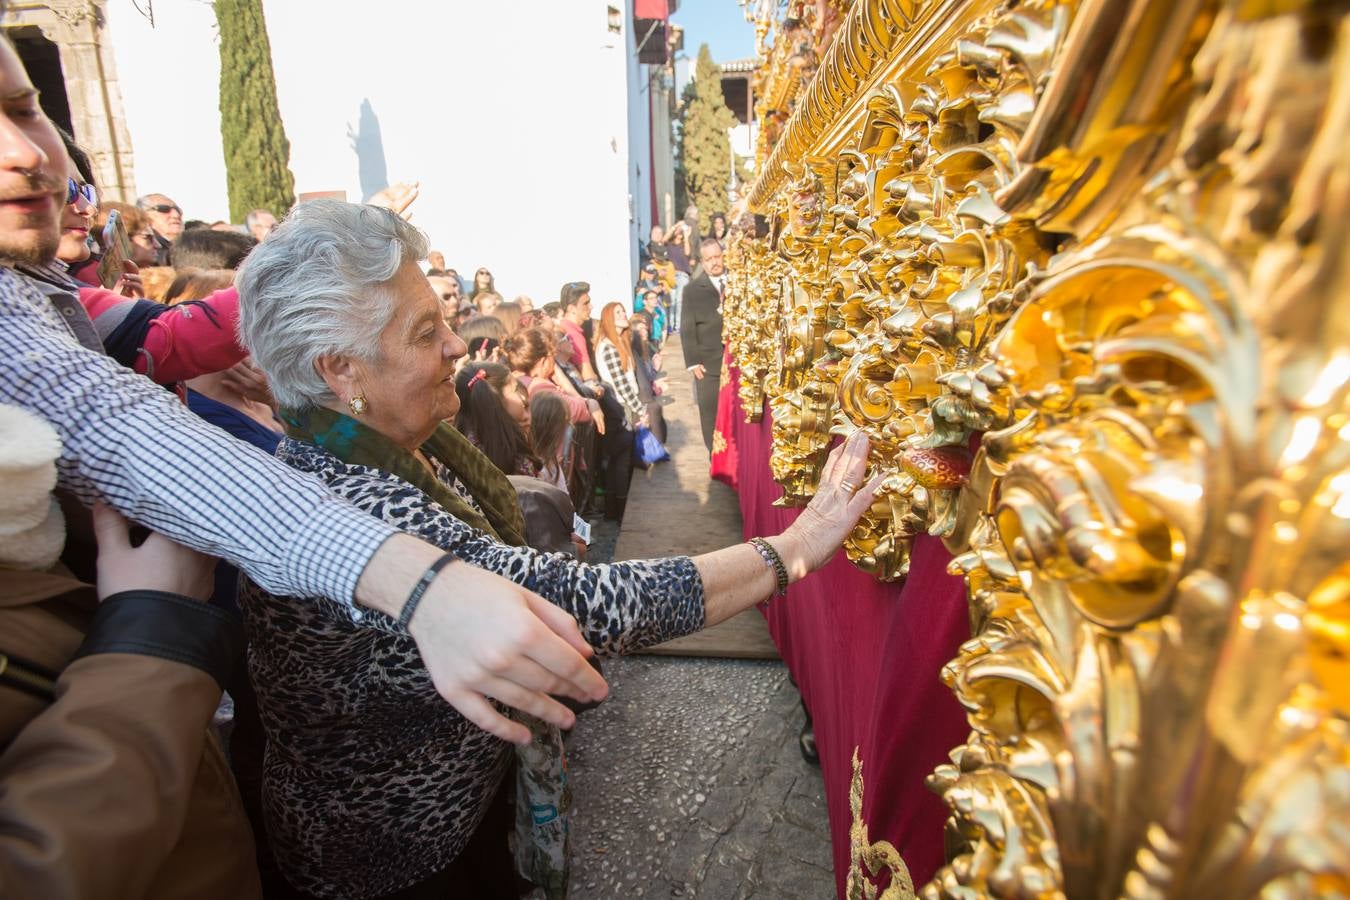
xmin=0 ymin=40 xmax=876 ymax=900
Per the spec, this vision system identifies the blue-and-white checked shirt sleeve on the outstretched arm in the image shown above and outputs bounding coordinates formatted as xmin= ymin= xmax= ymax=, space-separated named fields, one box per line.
xmin=0 ymin=269 xmax=394 ymax=609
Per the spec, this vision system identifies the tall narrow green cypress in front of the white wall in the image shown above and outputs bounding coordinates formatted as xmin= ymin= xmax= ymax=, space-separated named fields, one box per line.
xmin=213 ymin=0 xmax=296 ymax=223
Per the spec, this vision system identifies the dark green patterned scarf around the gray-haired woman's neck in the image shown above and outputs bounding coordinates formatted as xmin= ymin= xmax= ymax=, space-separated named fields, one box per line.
xmin=281 ymin=407 xmax=525 ymax=546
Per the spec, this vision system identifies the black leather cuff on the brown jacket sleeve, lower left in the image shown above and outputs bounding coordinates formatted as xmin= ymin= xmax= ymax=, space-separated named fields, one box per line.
xmin=76 ymin=591 xmax=244 ymax=690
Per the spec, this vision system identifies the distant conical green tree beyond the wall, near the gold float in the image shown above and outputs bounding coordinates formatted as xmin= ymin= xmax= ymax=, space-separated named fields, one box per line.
xmin=679 ymin=43 xmax=736 ymax=223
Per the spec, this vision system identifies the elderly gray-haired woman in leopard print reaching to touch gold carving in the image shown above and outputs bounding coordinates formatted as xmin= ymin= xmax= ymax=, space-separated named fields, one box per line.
xmin=238 ymin=200 xmax=875 ymax=897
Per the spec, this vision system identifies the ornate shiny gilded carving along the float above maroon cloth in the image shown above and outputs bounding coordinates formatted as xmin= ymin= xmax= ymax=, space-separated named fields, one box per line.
xmin=728 ymin=0 xmax=1350 ymax=899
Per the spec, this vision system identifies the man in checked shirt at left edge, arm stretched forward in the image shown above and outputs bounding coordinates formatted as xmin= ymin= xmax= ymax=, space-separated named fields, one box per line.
xmin=0 ymin=39 xmax=596 ymax=761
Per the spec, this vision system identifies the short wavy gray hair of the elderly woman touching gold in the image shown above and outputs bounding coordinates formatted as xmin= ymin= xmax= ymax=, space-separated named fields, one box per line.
xmin=235 ymin=200 xmax=428 ymax=410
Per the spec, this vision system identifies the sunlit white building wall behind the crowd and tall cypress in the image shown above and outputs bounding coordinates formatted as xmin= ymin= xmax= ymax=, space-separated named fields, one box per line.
xmin=108 ymin=0 xmax=649 ymax=309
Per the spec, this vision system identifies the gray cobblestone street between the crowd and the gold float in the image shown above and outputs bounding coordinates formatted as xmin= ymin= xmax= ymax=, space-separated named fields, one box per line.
xmin=568 ymin=339 xmax=834 ymax=900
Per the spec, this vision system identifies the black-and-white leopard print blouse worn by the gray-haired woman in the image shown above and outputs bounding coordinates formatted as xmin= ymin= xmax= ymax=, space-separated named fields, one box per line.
xmin=240 ymin=439 xmax=703 ymax=897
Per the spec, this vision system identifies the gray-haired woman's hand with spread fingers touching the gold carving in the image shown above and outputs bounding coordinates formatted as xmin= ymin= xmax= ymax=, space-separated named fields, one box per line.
xmin=783 ymin=432 xmax=883 ymax=572
